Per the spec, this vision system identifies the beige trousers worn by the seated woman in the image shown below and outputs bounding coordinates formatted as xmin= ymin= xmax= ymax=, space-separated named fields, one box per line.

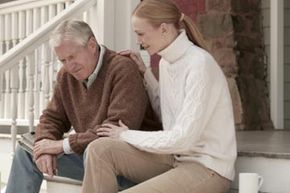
xmin=82 ymin=138 xmax=230 ymax=193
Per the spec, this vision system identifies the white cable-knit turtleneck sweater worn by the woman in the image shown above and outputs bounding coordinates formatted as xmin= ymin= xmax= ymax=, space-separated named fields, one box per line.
xmin=121 ymin=31 xmax=237 ymax=180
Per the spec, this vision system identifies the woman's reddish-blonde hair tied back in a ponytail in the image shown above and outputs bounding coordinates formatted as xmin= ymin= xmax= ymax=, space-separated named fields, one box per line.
xmin=132 ymin=0 xmax=207 ymax=49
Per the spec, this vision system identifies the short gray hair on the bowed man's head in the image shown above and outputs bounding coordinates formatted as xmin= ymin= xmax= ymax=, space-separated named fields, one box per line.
xmin=49 ymin=20 xmax=95 ymax=48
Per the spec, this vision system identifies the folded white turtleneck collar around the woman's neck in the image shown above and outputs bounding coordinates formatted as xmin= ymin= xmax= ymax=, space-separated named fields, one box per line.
xmin=158 ymin=30 xmax=193 ymax=64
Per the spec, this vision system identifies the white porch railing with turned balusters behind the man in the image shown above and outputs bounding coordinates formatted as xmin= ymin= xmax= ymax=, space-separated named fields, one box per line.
xmin=0 ymin=0 xmax=97 ymax=152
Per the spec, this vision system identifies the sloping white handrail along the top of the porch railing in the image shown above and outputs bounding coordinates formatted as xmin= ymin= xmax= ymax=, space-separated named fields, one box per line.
xmin=0 ymin=0 xmax=97 ymax=74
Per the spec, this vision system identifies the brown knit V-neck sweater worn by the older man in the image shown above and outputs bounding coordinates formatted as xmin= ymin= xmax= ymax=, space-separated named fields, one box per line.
xmin=36 ymin=49 xmax=161 ymax=154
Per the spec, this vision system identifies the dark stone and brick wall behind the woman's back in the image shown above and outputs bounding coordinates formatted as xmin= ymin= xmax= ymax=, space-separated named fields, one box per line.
xmin=152 ymin=0 xmax=273 ymax=130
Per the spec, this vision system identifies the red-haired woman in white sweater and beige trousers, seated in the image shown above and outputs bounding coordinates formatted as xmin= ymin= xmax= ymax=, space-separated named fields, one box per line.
xmin=83 ymin=0 xmax=236 ymax=193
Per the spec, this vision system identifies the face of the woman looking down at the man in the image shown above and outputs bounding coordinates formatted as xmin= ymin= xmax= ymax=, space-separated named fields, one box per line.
xmin=132 ymin=16 xmax=168 ymax=55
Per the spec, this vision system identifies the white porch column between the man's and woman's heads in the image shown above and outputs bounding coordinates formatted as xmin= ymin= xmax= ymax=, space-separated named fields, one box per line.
xmin=90 ymin=0 xmax=139 ymax=51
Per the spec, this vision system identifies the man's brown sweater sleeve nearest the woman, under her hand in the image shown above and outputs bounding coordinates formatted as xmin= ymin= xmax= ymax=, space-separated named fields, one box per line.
xmin=69 ymin=59 xmax=149 ymax=153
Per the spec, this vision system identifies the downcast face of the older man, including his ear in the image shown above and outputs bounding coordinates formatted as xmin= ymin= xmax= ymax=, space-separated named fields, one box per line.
xmin=54 ymin=38 xmax=98 ymax=81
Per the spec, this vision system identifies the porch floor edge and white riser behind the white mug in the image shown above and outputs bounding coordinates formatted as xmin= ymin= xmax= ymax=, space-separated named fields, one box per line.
xmin=232 ymin=130 xmax=290 ymax=193
